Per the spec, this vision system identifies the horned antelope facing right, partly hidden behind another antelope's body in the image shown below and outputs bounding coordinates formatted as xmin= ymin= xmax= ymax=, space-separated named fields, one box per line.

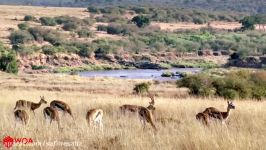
xmin=119 ymin=93 xmax=155 ymax=114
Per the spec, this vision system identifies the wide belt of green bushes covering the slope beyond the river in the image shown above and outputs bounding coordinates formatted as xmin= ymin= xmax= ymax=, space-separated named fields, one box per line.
xmin=7 ymin=15 xmax=266 ymax=61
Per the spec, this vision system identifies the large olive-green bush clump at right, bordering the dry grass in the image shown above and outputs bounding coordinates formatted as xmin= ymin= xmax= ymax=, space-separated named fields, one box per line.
xmin=177 ymin=70 xmax=266 ymax=100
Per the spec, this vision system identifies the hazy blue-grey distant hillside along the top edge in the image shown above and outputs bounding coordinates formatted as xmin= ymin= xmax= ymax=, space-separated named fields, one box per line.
xmin=0 ymin=0 xmax=266 ymax=13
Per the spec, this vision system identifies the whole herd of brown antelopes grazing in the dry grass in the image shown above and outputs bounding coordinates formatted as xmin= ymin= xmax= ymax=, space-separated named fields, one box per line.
xmin=14 ymin=93 xmax=235 ymax=131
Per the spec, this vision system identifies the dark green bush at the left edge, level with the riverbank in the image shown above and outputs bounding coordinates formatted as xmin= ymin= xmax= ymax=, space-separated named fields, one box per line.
xmin=0 ymin=50 xmax=18 ymax=74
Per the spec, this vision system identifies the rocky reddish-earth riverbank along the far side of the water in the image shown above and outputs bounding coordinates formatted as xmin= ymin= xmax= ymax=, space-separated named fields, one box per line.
xmin=18 ymin=54 xmax=222 ymax=74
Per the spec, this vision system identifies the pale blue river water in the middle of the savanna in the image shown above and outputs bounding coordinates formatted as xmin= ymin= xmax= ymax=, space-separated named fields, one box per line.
xmin=78 ymin=68 xmax=201 ymax=80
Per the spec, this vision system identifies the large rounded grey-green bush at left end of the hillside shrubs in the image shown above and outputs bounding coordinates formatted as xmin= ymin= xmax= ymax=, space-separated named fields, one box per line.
xmin=9 ymin=31 xmax=33 ymax=45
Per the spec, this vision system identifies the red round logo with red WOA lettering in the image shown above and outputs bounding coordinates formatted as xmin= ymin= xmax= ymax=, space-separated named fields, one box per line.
xmin=3 ymin=136 xmax=33 ymax=148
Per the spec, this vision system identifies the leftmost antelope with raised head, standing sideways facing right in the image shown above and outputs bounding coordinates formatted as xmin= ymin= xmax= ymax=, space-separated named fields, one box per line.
xmin=14 ymin=96 xmax=47 ymax=115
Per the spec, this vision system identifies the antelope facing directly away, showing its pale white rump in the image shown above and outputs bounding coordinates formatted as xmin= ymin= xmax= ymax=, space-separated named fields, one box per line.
xmin=86 ymin=109 xmax=103 ymax=130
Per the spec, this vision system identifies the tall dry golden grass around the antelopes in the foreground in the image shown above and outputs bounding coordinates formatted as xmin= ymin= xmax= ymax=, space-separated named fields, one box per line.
xmin=0 ymin=73 xmax=266 ymax=150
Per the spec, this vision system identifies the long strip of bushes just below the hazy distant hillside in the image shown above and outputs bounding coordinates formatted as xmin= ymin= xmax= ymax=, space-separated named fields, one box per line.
xmin=88 ymin=6 xmax=244 ymax=24
